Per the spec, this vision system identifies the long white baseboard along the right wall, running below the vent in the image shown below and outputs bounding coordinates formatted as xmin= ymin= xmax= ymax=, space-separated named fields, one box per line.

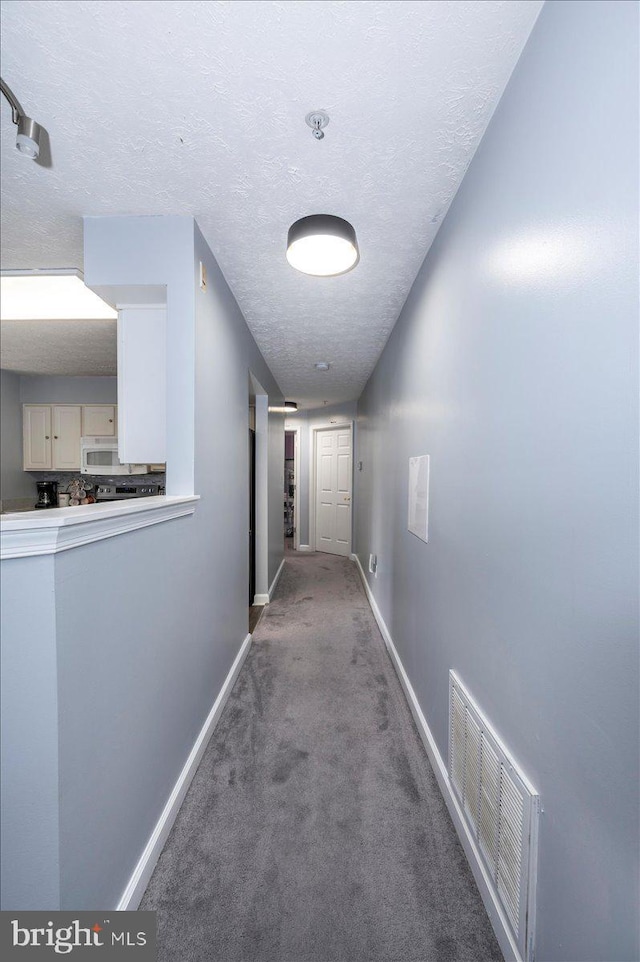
xmin=351 ymin=554 xmax=522 ymax=962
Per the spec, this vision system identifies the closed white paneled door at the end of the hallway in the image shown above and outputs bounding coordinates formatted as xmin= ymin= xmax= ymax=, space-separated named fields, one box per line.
xmin=315 ymin=425 xmax=352 ymax=557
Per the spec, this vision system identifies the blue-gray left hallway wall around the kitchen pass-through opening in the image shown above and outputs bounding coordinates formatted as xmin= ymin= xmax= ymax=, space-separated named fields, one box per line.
xmin=3 ymin=217 xmax=284 ymax=910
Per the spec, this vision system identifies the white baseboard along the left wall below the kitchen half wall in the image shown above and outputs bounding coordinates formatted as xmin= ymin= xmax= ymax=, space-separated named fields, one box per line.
xmin=116 ymin=635 xmax=251 ymax=912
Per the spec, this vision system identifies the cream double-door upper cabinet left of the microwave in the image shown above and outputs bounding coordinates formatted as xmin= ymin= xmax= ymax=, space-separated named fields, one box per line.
xmin=22 ymin=404 xmax=82 ymax=471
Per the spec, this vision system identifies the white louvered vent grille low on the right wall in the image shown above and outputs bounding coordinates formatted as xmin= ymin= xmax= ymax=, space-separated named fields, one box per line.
xmin=449 ymin=671 xmax=539 ymax=962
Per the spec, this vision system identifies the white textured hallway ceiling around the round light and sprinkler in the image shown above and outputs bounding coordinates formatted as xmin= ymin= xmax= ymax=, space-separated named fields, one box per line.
xmin=1 ymin=0 xmax=542 ymax=406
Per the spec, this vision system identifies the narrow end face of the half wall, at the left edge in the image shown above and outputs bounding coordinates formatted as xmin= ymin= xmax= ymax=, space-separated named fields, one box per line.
xmin=0 ymin=556 xmax=58 ymax=910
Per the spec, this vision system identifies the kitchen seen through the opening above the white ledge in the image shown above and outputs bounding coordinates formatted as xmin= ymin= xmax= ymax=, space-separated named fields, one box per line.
xmin=0 ymin=269 xmax=165 ymax=517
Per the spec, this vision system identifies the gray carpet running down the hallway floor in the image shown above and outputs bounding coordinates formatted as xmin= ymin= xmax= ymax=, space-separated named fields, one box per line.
xmin=140 ymin=553 xmax=502 ymax=962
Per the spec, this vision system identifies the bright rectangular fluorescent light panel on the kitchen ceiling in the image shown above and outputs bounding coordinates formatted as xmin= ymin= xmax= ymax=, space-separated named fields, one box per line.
xmin=0 ymin=271 xmax=118 ymax=321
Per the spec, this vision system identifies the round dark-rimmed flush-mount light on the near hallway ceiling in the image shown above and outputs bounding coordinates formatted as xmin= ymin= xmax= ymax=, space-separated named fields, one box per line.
xmin=287 ymin=214 xmax=360 ymax=277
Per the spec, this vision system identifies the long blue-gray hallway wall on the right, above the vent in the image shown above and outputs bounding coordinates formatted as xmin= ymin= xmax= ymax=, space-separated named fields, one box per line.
xmin=356 ymin=2 xmax=639 ymax=962
